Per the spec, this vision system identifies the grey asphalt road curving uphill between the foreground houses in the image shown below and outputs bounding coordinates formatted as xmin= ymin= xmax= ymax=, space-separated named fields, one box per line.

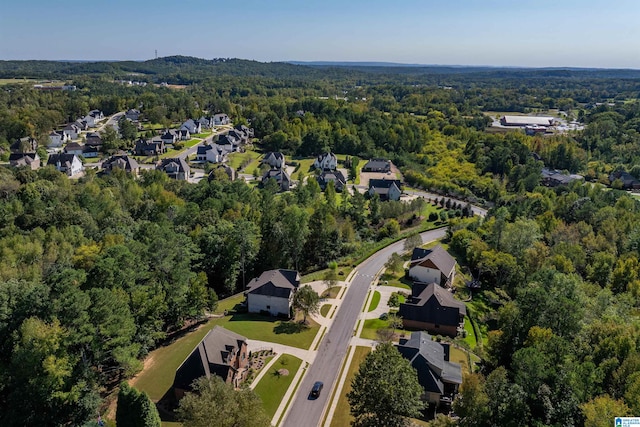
xmin=282 ymin=228 xmax=446 ymax=427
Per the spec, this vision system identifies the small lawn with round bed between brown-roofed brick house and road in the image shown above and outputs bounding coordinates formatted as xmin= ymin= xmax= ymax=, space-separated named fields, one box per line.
xmin=254 ymin=354 xmax=302 ymax=417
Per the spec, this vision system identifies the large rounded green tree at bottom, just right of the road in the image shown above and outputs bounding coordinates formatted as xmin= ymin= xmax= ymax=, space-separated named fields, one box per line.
xmin=347 ymin=343 xmax=424 ymax=426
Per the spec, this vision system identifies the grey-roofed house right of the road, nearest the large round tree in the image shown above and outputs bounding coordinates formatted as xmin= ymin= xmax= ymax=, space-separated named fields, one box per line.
xmin=397 ymin=331 xmax=462 ymax=407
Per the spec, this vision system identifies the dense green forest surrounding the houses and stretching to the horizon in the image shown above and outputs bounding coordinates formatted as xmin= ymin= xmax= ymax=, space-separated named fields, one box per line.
xmin=0 ymin=57 xmax=640 ymax=426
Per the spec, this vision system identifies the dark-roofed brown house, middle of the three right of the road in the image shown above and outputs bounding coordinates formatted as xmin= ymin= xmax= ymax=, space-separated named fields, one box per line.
xmin=398 ymin=283 xmax=467 ymax=337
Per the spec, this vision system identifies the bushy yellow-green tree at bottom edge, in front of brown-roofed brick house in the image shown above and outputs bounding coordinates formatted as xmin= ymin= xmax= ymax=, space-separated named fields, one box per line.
xmin=177 ymin=375 xmax=271 ymax=427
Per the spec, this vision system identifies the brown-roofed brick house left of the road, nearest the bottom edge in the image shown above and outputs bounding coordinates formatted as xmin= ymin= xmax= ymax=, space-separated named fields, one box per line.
xmin=173 ymin=326 xmax=249 ymax=399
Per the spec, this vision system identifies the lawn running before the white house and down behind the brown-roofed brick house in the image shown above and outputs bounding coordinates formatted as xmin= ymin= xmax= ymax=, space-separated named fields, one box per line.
xmin=130 ymin=295 xmax=320 ymax=401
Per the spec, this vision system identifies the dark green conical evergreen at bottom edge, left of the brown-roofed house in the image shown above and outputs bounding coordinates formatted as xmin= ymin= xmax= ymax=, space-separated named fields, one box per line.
xmin=116 ymin=381 xmax=161 ymax=427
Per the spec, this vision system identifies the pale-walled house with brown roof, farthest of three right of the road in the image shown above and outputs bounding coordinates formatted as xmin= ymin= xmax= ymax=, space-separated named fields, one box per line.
xmin=409 ymin=245 xmax=457 ymax=288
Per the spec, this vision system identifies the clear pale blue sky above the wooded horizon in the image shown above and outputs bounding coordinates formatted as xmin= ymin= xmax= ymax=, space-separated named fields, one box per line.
xmin=0 ymin=0 xmax=640 ymax=69
